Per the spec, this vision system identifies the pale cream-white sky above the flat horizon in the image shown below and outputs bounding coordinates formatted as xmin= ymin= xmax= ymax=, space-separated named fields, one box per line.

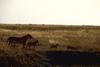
xmin=0 ymin=0 xmax=100 ymax=25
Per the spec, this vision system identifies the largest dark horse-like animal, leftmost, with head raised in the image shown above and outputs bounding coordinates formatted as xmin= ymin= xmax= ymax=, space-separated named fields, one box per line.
xmin=7 ymin=34 xmax=33 ymax=48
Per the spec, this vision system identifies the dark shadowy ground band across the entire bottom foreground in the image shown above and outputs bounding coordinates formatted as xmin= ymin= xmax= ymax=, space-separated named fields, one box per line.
xmin=0 ymin=51 xmax=100 ymax=67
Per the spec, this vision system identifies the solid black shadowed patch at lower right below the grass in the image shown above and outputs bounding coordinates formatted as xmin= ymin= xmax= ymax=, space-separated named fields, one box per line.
xmin=47 ymin=51 xmax=100 ymax=66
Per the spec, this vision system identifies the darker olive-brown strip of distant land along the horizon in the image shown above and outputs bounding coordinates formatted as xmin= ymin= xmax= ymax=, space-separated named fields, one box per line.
xmin=0 ymin=24 xmax=100 ymax=31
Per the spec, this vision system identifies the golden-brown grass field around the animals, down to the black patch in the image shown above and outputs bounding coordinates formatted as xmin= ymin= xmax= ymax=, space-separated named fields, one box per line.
xmin=0 ymin=24 xmax=100 ymax=67
